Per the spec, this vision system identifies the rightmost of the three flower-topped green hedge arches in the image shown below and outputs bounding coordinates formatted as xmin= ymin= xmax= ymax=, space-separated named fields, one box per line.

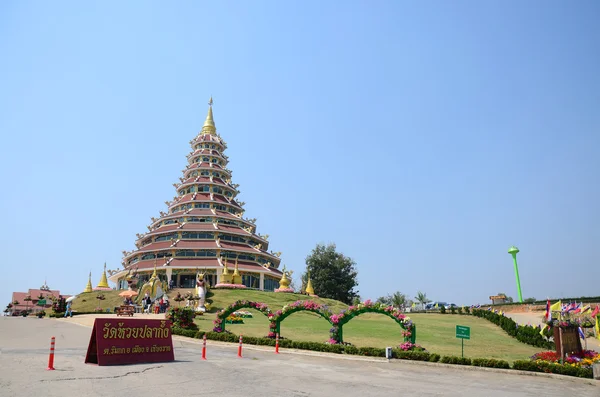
xmin=330 ymin=301 xmax=417 ymax=343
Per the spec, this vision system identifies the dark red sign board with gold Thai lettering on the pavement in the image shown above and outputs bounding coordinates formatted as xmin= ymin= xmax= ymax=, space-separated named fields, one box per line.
xmin=85 ymin=318 xmax=175 ymax=365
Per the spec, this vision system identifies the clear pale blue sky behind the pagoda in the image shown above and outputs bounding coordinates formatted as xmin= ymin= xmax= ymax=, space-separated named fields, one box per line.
xmin=0 ymin=0 xmax=600 ymax=305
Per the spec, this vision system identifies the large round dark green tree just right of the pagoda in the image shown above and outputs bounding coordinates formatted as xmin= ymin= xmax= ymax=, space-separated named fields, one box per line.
xmin=302 ymin=244 xmax=358 ymax=304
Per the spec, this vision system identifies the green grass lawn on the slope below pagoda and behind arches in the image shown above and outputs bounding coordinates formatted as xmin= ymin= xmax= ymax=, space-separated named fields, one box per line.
xmin=73 ymin=290 xmax=540 ymax=361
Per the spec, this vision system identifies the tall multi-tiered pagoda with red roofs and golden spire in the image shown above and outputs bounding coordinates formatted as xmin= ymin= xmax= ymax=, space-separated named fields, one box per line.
xmin=109 ymin=98 xmax=282 ymax=291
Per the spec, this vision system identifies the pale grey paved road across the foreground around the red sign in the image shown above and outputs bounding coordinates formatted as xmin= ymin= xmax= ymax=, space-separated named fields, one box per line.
xmin=0 ymin=317 xmax=600 ymax=397
